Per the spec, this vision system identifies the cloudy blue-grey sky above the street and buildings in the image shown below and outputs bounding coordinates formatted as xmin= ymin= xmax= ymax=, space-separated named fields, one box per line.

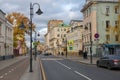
xmin=0 ymin=0 xmax=85 ymax=46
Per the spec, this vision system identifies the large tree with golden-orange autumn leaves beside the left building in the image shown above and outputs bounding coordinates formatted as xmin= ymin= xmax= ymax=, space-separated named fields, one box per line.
xmin=6 ymin=12 xmax=35 ymax=48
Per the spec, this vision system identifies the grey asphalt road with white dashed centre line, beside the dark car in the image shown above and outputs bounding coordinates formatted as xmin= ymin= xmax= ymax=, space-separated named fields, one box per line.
xmin=40 ymin=55 xmax=120 ymax=80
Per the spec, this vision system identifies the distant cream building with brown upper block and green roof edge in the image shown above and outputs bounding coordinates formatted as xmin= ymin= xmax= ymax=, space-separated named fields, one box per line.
xmin=45 ymin=20 xmax=69 ymax=55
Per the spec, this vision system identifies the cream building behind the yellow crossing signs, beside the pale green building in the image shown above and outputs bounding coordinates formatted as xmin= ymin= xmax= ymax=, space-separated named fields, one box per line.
xmin=67 ymin=20 xmax=83 ymax=56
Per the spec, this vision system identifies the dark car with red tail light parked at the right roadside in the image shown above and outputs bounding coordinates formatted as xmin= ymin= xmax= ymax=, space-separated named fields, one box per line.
xmin=96 ymin=55 xmax=120 ymax=69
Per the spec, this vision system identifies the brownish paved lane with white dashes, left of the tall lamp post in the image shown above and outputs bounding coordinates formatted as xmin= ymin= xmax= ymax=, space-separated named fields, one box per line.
xmin=0 ymin=58 xmax=29 ymax=80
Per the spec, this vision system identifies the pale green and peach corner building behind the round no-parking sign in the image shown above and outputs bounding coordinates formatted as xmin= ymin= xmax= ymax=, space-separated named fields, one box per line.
xmin=81 ymin=0 xmax=120 ymax=56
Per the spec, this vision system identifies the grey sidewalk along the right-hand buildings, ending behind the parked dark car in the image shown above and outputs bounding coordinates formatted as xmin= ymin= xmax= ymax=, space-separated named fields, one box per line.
xmin=59 ymin=56 xmax=99 ymax=65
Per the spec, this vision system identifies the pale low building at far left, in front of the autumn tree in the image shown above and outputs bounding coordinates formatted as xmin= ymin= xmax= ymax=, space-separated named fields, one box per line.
xmin=0 ymin=10 xmax=13 ymax=60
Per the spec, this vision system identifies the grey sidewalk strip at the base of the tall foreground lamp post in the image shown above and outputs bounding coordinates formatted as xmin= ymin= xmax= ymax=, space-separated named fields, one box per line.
xmin=20 ymin=58 xmax=42 ymax=80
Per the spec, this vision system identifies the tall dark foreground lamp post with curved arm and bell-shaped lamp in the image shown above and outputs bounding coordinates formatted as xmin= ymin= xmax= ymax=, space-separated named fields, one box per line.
xmin=29 ymin=3 xmax=43 ymax=72
